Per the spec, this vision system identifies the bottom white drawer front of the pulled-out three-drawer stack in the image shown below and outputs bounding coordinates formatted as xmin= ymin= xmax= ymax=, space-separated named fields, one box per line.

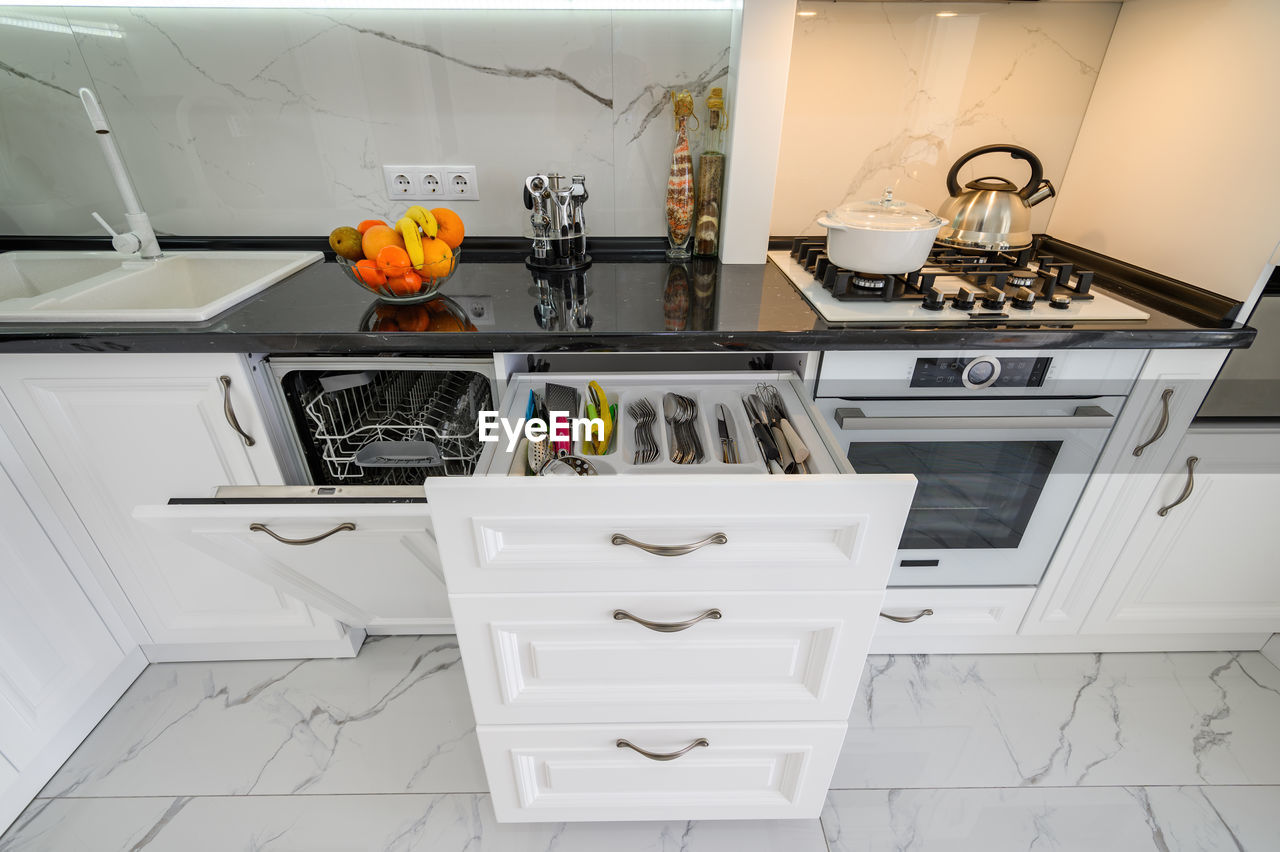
xmin=476 ymin=722 xmax=846 ymax=823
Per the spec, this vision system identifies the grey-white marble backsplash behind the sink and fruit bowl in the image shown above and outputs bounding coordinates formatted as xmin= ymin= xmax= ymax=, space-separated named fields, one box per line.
xmin=0 ymin=6 xmax=731 ymax=235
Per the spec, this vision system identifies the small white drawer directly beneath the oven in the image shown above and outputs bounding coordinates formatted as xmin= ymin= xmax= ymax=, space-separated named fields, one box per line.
xmin=872 ymin=586 xmax=1036 ymax=654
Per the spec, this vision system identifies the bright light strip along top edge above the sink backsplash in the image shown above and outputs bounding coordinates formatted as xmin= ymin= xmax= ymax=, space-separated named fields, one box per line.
xmin=0 ymin=0 xmax=742 ymax=12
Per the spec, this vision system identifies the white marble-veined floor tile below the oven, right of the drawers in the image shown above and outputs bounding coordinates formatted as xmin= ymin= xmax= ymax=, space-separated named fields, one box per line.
xmin=832 ymin=652 xmax=1280 ymax=789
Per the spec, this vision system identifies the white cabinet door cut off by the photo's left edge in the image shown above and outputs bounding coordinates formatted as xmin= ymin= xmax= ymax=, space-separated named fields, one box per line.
xmin=0 ymin=447 xmax=125 ymax=767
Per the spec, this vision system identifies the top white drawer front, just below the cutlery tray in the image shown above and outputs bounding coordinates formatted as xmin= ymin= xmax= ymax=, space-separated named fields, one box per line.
xmin=426 ymin=475 xmax=915 ymax=594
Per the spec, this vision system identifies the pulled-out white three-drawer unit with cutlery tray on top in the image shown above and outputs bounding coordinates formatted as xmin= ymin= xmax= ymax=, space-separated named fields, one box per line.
xmin=426 ymin=374 xmax=915 ymax=821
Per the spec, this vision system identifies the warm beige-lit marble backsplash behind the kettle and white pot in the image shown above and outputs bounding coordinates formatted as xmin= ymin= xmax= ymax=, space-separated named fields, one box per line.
xmin=771 ymin=0 xmax=1120 ymax=234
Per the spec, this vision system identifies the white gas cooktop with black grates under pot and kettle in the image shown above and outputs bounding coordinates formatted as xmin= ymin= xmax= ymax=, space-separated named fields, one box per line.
xmin=769 ymin=237 xmax=1151 ymax=325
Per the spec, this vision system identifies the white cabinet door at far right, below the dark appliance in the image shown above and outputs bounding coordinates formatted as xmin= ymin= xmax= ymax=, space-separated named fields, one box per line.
xmin=1083 ymin=429 xmax=1280 ymax=633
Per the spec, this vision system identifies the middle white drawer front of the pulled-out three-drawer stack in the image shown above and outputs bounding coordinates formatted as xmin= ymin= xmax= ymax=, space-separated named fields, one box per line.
xmin=451 ymin=591 xmax=882 ymax=724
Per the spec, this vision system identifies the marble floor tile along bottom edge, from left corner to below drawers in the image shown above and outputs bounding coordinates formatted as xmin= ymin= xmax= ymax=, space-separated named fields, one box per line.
xmin=0 ymin=794 xmax=827 ymax=852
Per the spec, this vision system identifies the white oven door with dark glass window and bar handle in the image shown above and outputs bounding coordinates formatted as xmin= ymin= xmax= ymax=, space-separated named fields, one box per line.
xmin=818 ymin=397 xmax=1124 ymax=586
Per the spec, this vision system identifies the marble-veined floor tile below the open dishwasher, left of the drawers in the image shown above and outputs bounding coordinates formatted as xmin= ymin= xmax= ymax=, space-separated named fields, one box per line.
xmin=41 ymin=636 xmax=488 ymax=797
